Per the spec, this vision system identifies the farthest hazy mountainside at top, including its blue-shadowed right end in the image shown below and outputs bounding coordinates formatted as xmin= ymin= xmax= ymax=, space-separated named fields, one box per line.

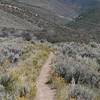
xmin=14 ymin=0 xmax=99 ymax=17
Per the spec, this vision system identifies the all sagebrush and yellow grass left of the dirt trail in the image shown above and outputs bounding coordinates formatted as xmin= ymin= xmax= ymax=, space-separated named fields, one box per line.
xmin=0 ymin=37 xmax=51 ymax=100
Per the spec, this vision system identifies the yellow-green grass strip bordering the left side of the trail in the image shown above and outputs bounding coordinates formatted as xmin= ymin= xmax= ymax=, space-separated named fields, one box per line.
xmin=0 ymin=43 xmax=51 ymax=100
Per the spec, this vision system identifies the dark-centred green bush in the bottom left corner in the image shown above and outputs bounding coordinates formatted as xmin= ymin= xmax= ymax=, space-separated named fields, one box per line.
xmin=0 ymin=74 xmax=15 ymax=100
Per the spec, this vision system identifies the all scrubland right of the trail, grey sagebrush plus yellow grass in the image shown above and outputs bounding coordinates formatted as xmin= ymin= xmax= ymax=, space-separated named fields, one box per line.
xmin=49 ymin=42 xmax=100 ymax=100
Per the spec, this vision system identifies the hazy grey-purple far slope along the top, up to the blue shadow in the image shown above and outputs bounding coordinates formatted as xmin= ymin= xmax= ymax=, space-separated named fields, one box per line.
xmin=1 ymin=0 xmax=79 ymax=20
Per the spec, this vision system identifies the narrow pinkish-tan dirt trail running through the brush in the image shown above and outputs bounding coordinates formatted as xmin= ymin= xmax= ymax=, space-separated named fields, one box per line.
xmin=35 ymin=53 xmax=55 ymax=100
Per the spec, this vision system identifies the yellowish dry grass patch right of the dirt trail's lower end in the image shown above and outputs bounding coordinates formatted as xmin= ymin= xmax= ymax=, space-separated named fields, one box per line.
xmin=50 ymin=73 xmax=68 ymax=100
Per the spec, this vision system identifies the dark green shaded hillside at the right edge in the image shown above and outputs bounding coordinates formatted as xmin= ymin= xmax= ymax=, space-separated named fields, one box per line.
xmin=67 ymin=7 xmax=100 ymax=42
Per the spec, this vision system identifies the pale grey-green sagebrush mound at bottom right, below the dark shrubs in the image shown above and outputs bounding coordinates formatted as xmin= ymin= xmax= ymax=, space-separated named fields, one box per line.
xmin=69 ymin=85 xmax=97 ymax=100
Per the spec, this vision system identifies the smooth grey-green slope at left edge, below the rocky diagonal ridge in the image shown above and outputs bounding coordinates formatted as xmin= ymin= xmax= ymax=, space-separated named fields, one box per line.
xmin=0 ymin=10 xmax=36 ymax=30
